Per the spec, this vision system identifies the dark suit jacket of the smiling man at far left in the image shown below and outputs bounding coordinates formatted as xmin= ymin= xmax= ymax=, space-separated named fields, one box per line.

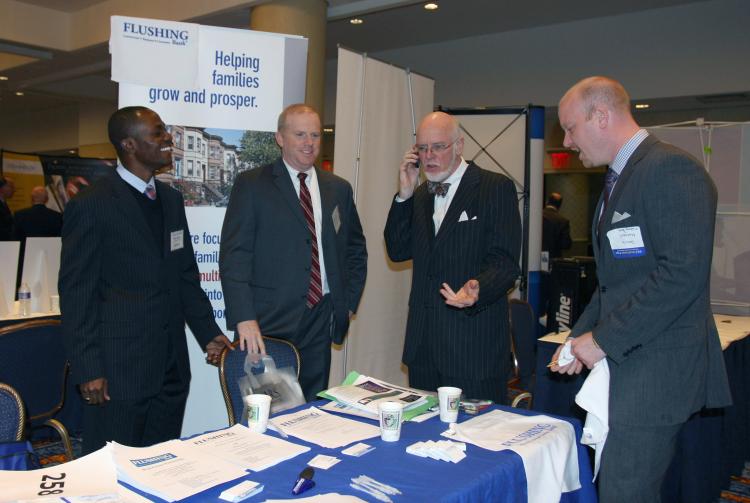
xmin=59 ymin=171 xmax=221 ymax=400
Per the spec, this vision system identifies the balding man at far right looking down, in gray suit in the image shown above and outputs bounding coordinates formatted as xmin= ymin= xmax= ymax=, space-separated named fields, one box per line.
xmin=552 ymin=77 xmax=731 ymax=503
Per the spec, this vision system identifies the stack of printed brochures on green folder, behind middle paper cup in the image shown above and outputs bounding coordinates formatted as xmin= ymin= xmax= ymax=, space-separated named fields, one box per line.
xmin=318 ymin=372 xmax=438 ymax=421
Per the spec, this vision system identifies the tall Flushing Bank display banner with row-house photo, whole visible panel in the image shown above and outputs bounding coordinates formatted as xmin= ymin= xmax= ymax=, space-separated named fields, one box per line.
xmin=109 ymin=16 xmax=308 ymax=435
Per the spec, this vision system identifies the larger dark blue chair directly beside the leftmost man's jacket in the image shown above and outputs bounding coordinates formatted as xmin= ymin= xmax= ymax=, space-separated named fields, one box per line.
xmin=0 ymin=319 xmax=73 ymax=460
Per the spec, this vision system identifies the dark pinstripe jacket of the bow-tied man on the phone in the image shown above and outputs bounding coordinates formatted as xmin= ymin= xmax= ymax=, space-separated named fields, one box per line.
xmin=385 ymin=163 xmax=521 ymax=379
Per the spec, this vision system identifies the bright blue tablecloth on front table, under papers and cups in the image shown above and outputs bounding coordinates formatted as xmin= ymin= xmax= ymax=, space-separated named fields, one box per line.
xmin=126 ymin=402 xmax=596 ymax=503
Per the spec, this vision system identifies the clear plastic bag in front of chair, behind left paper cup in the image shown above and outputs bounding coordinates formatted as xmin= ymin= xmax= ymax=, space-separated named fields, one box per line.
xmin=237 ymin=353 xmax=305 ymax=423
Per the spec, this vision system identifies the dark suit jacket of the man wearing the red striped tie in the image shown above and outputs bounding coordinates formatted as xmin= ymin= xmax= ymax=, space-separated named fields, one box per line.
xmin=219 ymin=159 xmax=367 ymax=344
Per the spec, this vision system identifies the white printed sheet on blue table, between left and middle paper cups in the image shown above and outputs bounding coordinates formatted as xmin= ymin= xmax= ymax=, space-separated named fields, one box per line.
xmin=274 ymin=407 xmax=380 ymax=449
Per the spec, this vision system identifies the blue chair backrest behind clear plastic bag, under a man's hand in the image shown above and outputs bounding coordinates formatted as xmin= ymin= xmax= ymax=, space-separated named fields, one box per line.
xmin=219 ymin=336 xmax=300 ymax=426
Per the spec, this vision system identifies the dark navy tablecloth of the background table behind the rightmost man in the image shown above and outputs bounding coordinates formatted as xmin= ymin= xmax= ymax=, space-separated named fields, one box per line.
xmin=534 ymin=337 xmax=750 ymax=503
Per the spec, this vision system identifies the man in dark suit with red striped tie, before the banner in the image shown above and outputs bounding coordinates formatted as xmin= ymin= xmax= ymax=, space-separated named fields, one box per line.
xmin=219 ymin=104 xmax=367 ymax=401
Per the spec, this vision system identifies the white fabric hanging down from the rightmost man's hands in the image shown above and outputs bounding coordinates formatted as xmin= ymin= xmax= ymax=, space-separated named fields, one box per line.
xmin=576 ymin=358 xmax=609 ymax=480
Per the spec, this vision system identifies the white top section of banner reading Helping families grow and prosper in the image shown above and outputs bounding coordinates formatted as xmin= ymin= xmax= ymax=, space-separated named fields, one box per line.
xmin=109 ymin=16 xmax=307 ymax=131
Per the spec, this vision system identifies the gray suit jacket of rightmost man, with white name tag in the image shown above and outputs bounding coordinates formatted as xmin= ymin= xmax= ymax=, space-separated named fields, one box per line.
xmin=572 ymin=136 xmax=731 ymax=425
